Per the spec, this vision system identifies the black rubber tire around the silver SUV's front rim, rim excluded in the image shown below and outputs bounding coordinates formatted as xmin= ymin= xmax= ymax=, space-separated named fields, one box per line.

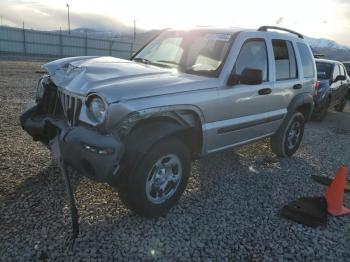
xmin=118 ymin=138 xmax=191 ymax=217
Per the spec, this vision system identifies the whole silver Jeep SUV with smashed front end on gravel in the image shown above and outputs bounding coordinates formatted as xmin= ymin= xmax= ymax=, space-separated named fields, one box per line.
xmin=21 ymin=26 xmax=316 ymax=216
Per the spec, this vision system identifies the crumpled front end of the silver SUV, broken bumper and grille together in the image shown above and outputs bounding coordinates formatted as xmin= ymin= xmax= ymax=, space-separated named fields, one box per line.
xmin=20 ymin=74 xmax=124 ymax=183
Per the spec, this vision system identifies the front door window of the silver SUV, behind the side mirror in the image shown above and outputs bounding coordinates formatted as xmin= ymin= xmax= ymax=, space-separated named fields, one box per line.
xmin=232 ymin=39 xmax=268 ymax=81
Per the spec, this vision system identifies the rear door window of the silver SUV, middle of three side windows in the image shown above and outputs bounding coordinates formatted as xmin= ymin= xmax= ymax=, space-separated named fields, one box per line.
xmin=272 ymin=39 xmax=297 ymax=80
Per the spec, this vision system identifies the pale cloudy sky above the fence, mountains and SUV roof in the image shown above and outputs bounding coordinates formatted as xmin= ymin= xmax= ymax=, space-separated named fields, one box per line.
xmin=0 ymin=0 xmax=350 ymax=46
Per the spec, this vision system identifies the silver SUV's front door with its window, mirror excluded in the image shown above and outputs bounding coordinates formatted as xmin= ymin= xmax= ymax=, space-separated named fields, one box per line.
xmin=205 ymin=38 xmax=287 ymax=152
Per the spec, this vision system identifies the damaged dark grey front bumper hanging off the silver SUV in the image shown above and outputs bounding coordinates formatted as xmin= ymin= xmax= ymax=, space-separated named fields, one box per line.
xmin=20 ymin=105 xmax=124 ymax=184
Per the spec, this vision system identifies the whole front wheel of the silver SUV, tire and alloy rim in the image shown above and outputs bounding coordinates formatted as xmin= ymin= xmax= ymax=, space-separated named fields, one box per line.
xmin=119 ymin=139 xmax=191 ymax=217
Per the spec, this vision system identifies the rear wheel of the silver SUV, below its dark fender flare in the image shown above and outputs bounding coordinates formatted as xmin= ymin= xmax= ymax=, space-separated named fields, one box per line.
xmin=270 ymin=112 xmax=305 ymax=157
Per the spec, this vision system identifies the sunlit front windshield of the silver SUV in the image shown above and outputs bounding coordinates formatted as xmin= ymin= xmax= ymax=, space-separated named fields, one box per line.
xmin=134 ymin=30 xmax=232 ymax=76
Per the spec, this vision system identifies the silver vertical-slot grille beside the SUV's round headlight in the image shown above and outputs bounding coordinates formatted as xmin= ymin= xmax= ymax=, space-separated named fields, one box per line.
xmin=56 ymin=90 xmax=82 ymax=127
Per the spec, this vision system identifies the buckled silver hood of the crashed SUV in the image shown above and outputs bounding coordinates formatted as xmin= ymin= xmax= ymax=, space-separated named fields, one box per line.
xmin=44 ymin=56 xmax=217 ymax=102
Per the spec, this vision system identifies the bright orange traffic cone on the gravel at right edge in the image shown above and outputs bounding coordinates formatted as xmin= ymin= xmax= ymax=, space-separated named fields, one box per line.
xmin=325 ymin=165 xmax=350 ymax=216
